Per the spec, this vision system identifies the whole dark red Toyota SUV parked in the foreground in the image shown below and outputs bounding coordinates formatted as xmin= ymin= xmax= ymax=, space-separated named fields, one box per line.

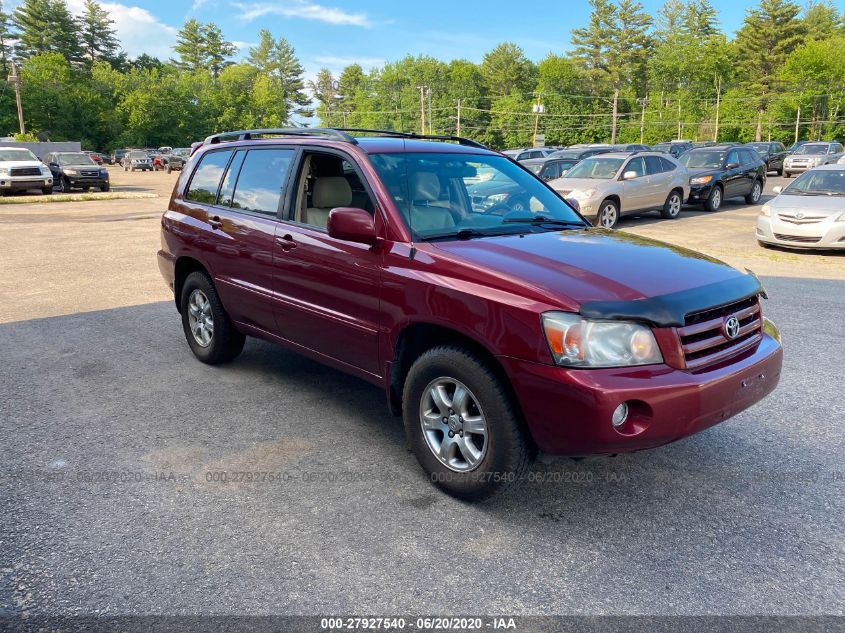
xmin=158 ymin=129 xmax=782 ymax=499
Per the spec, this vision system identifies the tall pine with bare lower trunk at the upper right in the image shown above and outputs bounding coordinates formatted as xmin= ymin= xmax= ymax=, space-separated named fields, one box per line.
xmin=736 ymin=0 xmax=804 ymax=141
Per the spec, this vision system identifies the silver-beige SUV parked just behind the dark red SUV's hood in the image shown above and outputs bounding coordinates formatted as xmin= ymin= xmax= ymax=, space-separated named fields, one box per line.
xmin=549 ymin=152 xmax=689 ymax=229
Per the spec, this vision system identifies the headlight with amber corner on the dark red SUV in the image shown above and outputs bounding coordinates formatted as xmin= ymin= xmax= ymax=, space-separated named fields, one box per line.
xmin=542 ymin=312 xmax=663 ymax=367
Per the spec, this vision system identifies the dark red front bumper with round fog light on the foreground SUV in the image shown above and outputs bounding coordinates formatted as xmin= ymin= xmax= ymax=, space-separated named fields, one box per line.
xmin=499 ymin=335 xmax=783 ymax=455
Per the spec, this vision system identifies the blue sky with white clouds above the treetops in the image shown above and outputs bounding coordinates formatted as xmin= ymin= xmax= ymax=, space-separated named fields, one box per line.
xmin=3 ymin=0 xmax=845 ymax=77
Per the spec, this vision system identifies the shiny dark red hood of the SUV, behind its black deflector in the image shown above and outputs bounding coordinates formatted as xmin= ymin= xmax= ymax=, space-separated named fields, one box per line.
xmin=430 ymin=229 xmax=745 ymax=311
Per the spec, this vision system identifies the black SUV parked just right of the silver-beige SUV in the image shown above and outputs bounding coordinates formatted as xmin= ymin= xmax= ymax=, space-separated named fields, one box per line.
xmin=679 ymin=145 xmax=766 ymax=211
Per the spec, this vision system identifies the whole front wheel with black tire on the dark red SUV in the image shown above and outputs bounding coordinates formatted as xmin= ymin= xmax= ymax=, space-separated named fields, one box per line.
xmin=402 ymin=345 xmax=534 ymax=501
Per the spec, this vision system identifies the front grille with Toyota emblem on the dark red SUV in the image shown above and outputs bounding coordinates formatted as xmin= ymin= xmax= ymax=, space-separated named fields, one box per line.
xmin=678 ymin=296 xmax=763 ymax=370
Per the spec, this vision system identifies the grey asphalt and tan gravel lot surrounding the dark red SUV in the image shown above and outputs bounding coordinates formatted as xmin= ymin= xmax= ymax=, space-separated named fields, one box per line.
xmin=0 ymin=164 xmax=845 ymax=615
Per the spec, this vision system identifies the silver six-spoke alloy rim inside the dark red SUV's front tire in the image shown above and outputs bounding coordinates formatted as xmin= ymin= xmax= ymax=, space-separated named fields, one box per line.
xmin=420 ymin=376 xmax=489 ymax=472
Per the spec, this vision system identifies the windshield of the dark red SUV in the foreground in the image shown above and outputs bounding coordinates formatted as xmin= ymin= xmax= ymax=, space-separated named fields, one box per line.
xmin=370 ymin=152 xmax=585 ymax=240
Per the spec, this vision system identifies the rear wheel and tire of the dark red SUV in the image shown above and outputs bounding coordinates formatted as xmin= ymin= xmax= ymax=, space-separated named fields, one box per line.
xmin=179 ymin=272 xmax=246 ymax=365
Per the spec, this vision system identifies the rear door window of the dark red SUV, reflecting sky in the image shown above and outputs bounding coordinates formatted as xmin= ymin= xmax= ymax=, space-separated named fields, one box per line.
xmin=230 ymin=148 xmax=295 ymax=215
